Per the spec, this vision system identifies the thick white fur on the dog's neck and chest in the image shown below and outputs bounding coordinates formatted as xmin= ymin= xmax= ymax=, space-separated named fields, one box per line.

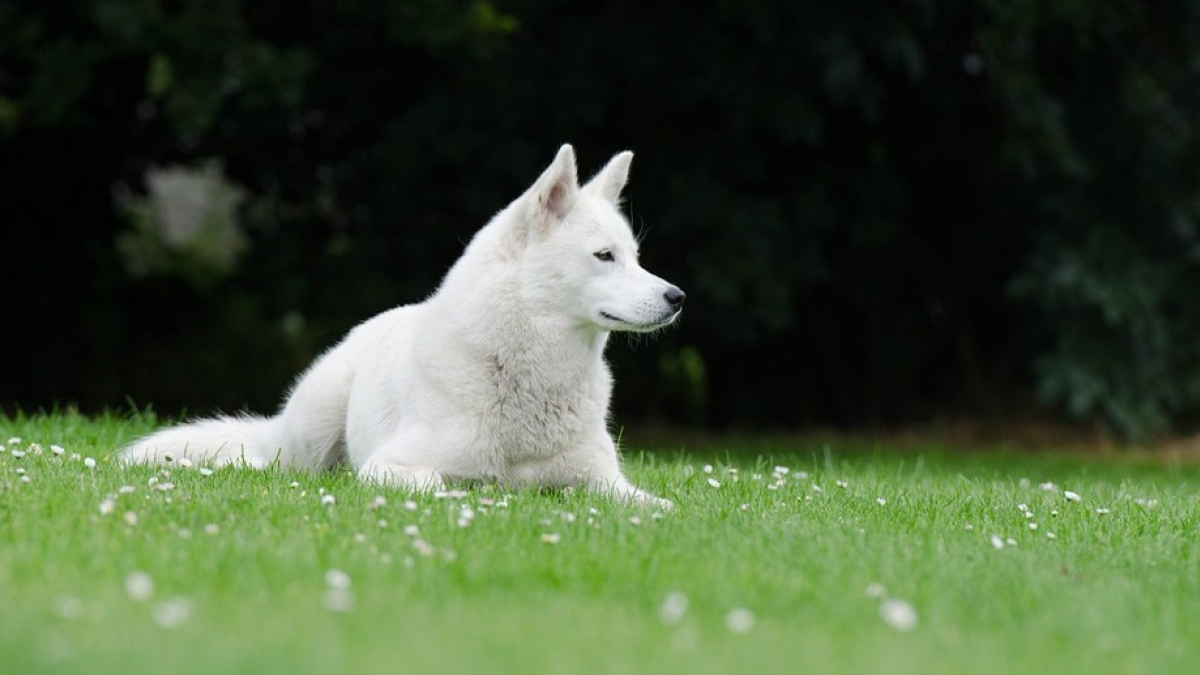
xmin=418 ymin=204 xmax=612 ymax=456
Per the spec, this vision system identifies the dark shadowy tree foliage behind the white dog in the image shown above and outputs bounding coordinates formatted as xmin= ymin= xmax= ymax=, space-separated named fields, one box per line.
xmin=0 ymin=0 xmax=1200 ymax=436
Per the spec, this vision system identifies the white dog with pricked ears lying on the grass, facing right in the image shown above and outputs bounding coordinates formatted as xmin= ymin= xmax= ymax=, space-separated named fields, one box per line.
xmin=122 ymin=145 xmax=684 ymax=506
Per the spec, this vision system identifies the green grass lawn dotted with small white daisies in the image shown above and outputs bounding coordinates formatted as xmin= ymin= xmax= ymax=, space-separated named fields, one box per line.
xmin=0 ymin=413 xmax=1200 ymax=674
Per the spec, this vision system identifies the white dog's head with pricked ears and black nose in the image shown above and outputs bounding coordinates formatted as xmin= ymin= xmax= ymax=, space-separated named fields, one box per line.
xmin=521 ymin=145 xmax=685 ymax=333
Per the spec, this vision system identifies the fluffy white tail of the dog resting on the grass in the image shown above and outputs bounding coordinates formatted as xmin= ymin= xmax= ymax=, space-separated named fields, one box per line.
xmin=118 ymin=416 xmax=282 ymax=468
